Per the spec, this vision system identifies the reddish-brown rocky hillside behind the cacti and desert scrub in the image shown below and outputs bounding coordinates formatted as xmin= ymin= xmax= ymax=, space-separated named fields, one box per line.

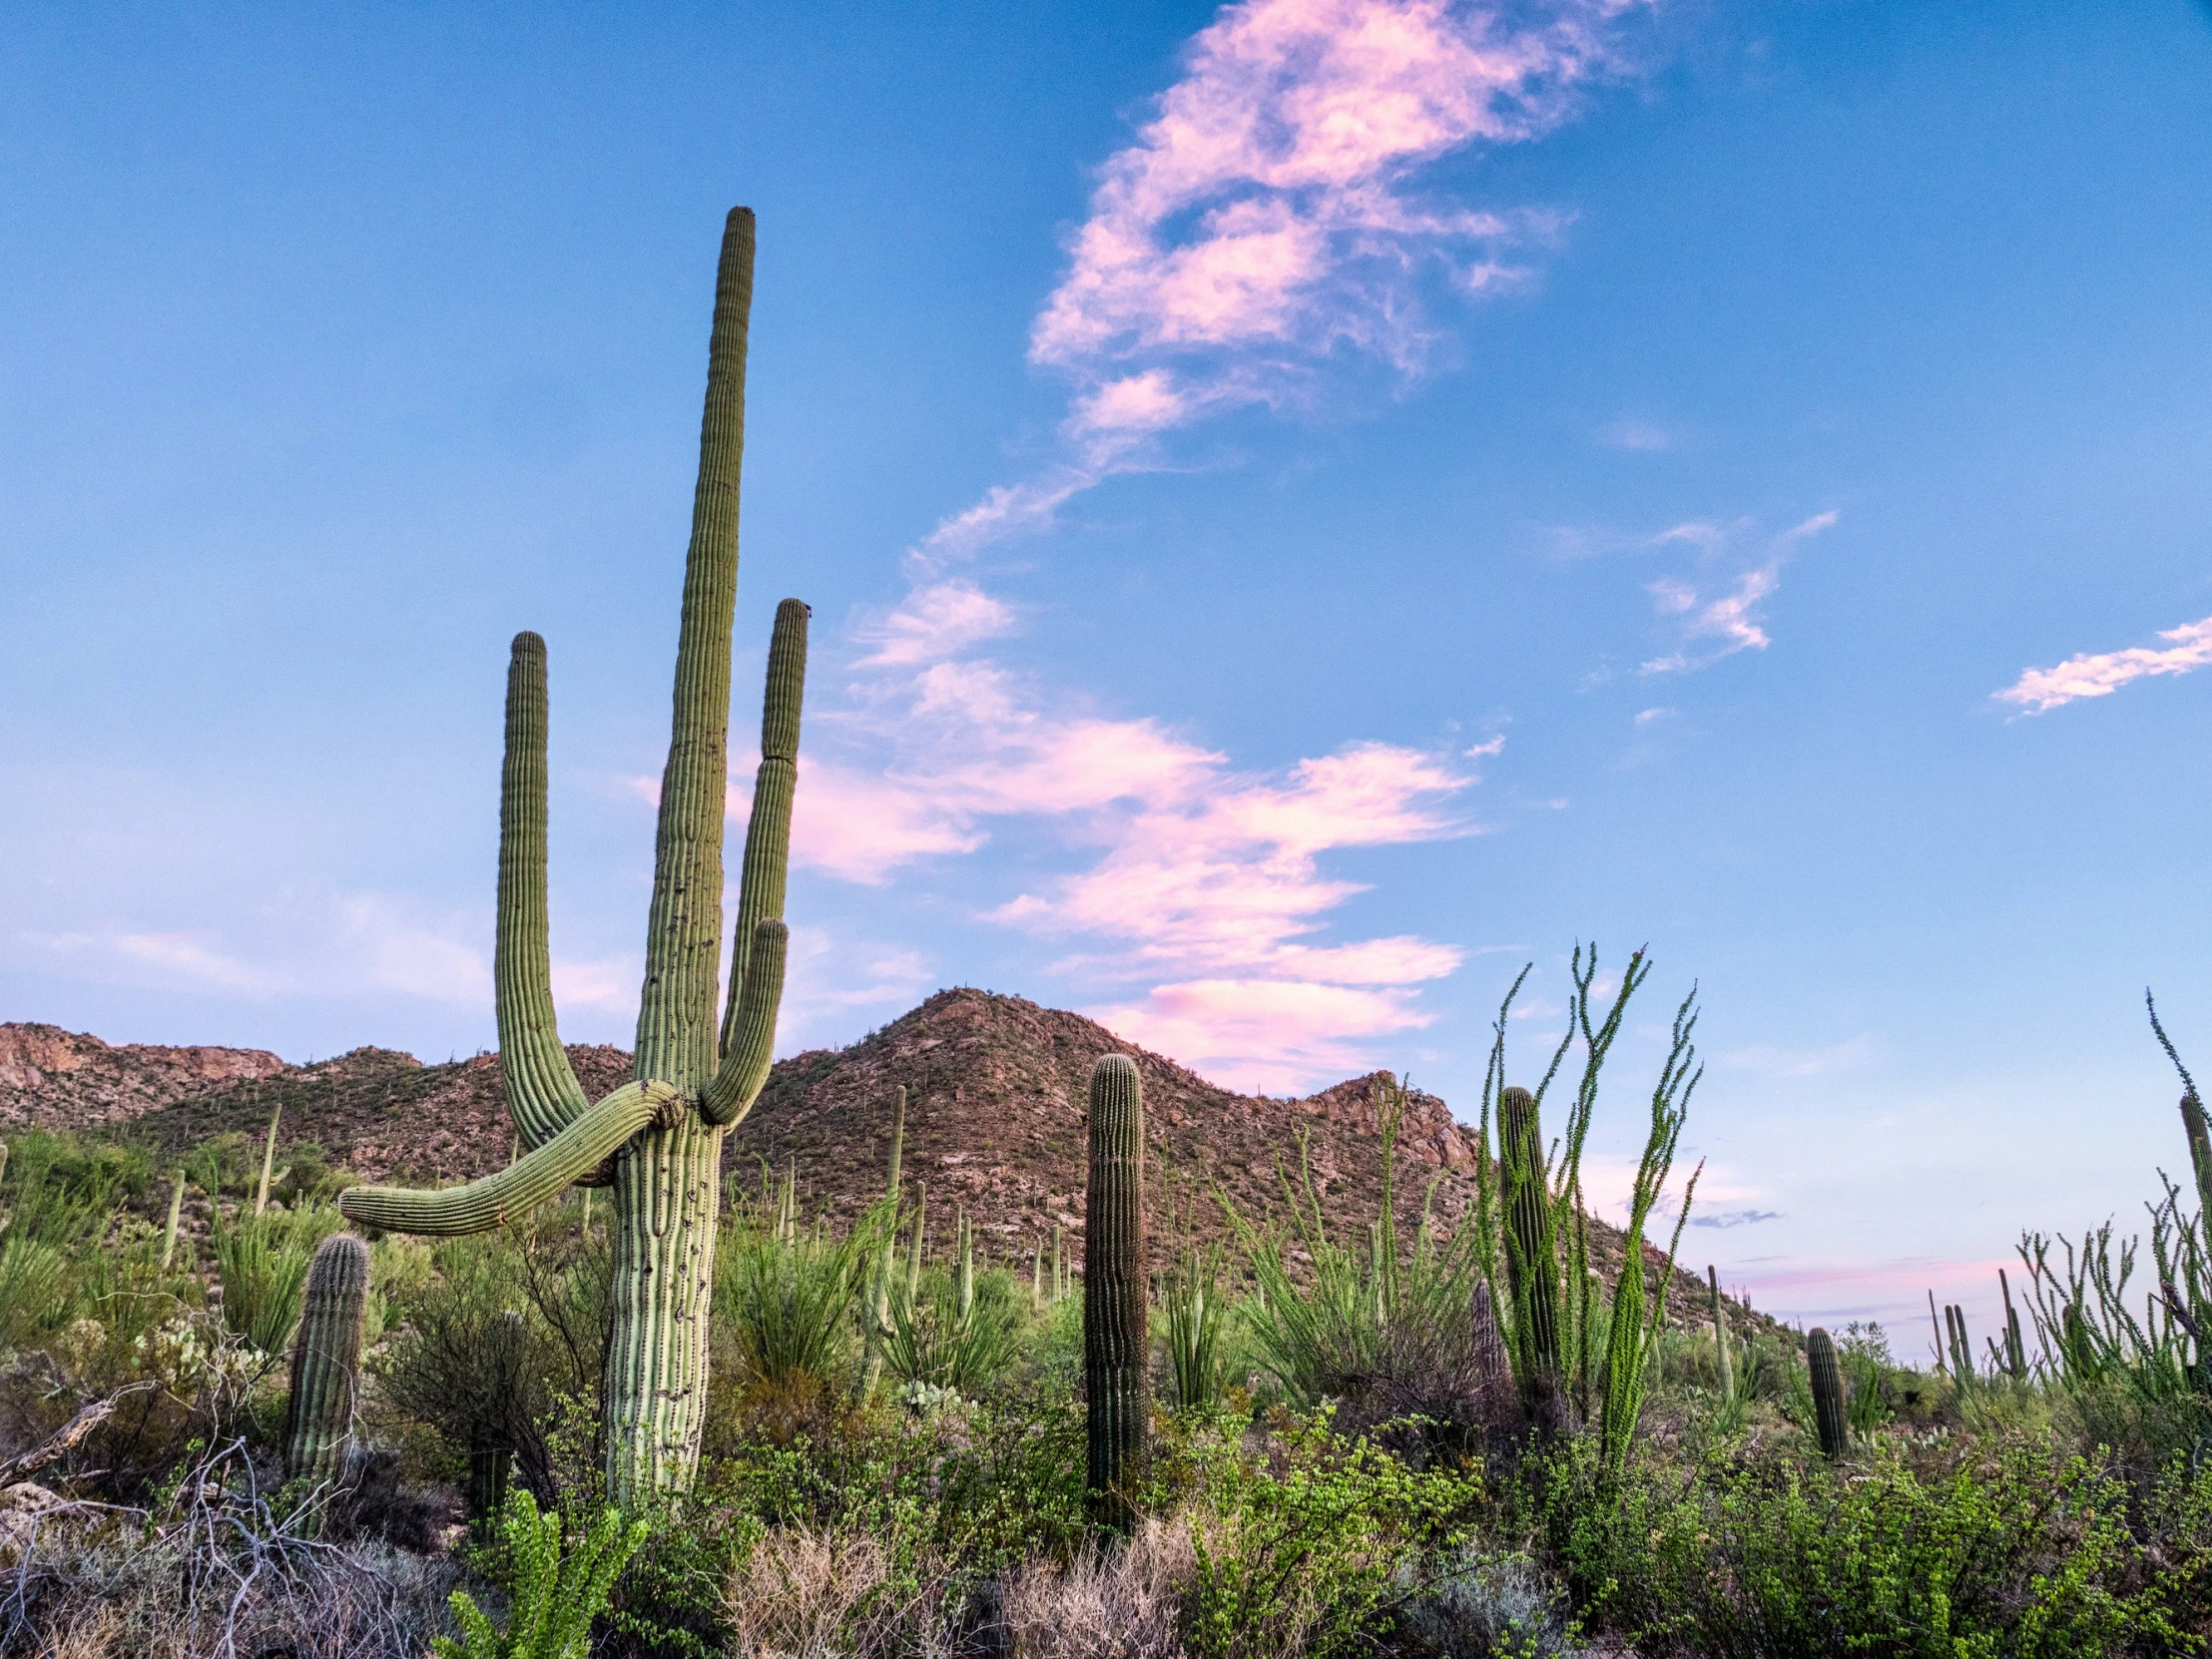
xmin=0 ymin=989 xmax=1698 ymax=1318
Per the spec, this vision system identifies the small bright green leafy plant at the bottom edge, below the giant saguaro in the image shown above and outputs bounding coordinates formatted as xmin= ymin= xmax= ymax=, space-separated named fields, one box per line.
xmin=429 ymin=1488 xmax=651 ymax=1659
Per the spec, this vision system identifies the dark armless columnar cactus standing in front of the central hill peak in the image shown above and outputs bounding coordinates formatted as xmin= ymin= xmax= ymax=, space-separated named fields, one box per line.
xmin=1084 ymin=1055 xmax=1153 ymax=1528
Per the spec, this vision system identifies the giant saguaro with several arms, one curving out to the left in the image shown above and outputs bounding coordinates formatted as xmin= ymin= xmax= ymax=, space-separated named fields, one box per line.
xmin=340 ymin=208 xmax=808 ymax=1506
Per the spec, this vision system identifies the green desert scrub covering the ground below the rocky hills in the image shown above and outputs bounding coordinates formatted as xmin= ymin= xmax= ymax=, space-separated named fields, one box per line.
xmin=0 ymin=981 xmax=2212 ymax=1659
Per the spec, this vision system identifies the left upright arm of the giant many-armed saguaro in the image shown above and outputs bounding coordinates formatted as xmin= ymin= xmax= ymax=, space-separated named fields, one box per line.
xmin=491 ymin=633 xmax=591 ymax=1148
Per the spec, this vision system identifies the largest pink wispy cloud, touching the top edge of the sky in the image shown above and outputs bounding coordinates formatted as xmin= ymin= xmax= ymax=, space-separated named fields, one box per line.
xmin=918 ymin=0 xmax=1643 ymax=569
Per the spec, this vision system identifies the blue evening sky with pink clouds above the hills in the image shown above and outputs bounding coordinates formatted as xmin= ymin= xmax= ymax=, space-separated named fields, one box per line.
xmin=0 ymin=0 xmax=2212 ymax=1361
